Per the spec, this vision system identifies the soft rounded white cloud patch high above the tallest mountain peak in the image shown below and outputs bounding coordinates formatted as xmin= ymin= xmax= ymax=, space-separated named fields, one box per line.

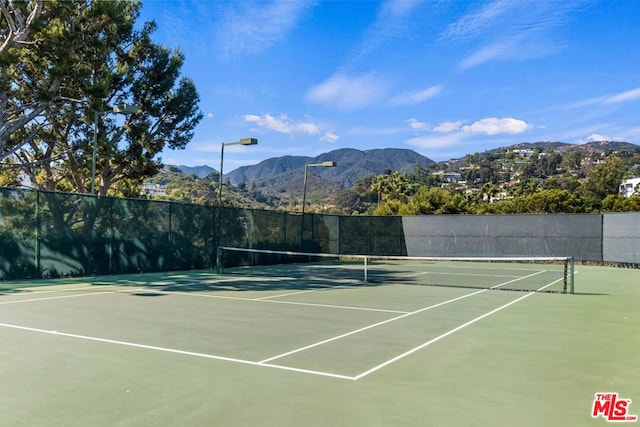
xmin=307 ymin=74 xmax=388 ymax=110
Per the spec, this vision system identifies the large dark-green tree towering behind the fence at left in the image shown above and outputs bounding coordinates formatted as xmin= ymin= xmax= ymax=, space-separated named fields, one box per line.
xmin=0 ymin=0 xmax=202 ymax=196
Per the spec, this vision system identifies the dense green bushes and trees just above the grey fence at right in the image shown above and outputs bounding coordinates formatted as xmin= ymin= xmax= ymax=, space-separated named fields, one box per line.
xmin=362 ymin=152 xmax=640 ymax=215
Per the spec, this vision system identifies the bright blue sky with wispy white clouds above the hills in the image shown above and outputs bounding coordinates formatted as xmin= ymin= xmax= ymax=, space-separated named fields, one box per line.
xmin=140 ymin=0 xmax=640 ymax=171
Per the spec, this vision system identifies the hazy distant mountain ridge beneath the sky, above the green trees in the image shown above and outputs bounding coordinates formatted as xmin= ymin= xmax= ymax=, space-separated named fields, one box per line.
xmin=165 ymin=141 xmax=640 ymax=207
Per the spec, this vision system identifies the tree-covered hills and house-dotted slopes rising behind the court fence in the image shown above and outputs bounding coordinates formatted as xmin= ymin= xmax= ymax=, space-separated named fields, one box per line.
xmin=153 ymin=141 xmax=640 ymax=213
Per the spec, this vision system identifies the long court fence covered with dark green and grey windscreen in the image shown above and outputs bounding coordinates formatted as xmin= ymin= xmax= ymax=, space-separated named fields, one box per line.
xmin=0 ymin=188 xmax=640 ymax=280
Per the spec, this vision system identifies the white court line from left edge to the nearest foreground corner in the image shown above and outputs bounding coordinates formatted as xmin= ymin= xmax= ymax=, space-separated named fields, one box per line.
xmin=0 ymin=323 xmax=354 ymax=381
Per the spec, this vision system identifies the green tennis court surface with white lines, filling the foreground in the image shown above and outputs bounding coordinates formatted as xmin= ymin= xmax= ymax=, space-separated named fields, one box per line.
xmin=0 ymin=265 xmax=640 ymax=427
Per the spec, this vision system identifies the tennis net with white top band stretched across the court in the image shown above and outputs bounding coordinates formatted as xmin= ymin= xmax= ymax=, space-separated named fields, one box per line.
xmin=217 ymin=247 xmax=574 ymax=293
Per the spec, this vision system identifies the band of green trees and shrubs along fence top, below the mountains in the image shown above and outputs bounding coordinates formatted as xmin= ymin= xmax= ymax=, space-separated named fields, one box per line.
xmin=141 ymin=150 xmax=639 ymax=215
